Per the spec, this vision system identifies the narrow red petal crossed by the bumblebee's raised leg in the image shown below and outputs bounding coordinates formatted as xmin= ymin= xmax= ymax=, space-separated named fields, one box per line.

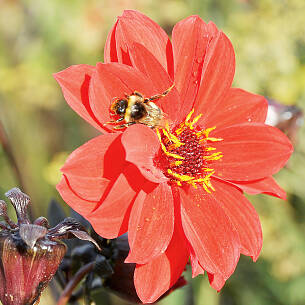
xmin=126 ymin=43 xmax=180 ymax=123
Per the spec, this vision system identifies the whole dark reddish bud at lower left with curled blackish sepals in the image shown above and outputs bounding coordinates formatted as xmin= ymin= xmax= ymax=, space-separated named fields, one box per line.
xmin=0 ymin=188 xmax=99 ymax=305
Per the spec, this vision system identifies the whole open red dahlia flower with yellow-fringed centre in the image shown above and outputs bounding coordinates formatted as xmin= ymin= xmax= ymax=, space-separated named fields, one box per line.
xmin=55 ymin=11 xmax=293 ymax=302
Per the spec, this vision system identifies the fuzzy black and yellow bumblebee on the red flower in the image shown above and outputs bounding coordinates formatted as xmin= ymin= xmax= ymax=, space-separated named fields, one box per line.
xmin=107 ymin=85 xmax=174 ymax=129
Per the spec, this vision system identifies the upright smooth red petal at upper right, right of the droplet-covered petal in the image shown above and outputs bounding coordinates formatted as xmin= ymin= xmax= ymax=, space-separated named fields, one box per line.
xmin=194 ymin=32 xmax=235 ymax=125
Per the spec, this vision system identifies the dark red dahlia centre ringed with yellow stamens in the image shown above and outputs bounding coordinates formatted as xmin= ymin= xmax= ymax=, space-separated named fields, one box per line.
xmin=154 ymin=110 xmax=223 ymax=193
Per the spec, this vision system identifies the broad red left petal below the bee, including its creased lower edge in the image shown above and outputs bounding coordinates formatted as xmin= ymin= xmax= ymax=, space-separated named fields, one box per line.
xmin=57 ymin=134 xmax=126 ymax=218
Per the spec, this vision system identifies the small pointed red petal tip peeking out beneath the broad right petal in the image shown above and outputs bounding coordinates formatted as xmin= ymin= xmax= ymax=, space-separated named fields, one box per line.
xmin=230 ymin=177 xmax=286 ymax=200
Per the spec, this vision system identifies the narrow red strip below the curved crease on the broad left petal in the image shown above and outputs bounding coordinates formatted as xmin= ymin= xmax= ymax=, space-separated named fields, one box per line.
xmin=56 ymin=176 xmax=97 ymax=217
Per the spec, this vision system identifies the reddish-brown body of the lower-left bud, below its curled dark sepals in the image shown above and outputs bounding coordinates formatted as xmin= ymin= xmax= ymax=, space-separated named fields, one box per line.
xmin=0 ymin=231 xmax=66 ymax=305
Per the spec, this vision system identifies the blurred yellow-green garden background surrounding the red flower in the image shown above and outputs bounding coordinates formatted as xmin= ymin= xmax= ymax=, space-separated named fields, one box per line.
xmin=0 ymin=0 xmax=305 ymax=305
